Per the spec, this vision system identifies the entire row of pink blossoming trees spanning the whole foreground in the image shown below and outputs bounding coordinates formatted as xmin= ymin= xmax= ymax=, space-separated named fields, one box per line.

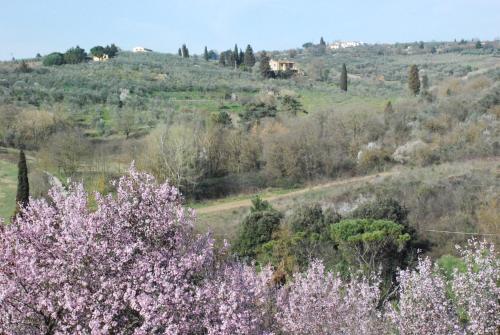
xmin=0 ymin=168 xmax=500 ymax=335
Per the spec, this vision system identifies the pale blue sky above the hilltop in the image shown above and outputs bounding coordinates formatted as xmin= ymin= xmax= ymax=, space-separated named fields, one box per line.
xmin=0 ymin=0 xmax=500 ymax=59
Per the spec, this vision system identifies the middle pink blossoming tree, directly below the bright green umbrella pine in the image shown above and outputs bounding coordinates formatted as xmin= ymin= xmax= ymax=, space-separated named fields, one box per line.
xmin=276 ymin=262 xmax=381 ymax=335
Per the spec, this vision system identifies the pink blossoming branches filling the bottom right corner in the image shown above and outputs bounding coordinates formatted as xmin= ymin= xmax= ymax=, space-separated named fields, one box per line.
xmin=387 ymin=239 xmax=500 ymax=335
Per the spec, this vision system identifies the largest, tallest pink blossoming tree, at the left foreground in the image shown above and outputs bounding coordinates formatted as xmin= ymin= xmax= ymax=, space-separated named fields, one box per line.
xmin=0 ymin=168 xmax=214 ymax=334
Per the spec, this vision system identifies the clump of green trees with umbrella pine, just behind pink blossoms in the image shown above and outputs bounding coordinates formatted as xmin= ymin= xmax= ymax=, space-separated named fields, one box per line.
xmin=233 ymin=197 xmax=430 ymax=284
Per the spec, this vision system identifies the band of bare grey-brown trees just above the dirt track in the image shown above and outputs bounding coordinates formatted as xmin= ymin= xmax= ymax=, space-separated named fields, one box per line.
xmin=138 ymin=79 xmax=499 ymax=198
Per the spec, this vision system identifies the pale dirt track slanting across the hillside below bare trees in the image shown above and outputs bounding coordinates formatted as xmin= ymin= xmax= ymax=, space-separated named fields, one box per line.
xmin=196 ymin=171 xmax=397 ymax=214
